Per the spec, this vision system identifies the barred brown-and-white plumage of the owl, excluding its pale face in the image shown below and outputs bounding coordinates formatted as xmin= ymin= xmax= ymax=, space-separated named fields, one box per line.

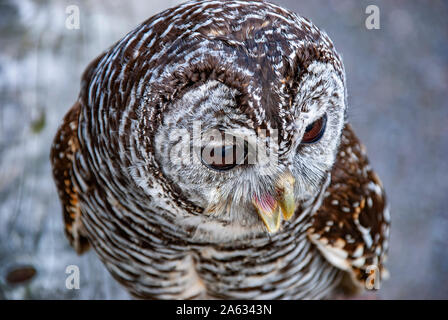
xmin=51 ymin=1 xmax=389 ymax=299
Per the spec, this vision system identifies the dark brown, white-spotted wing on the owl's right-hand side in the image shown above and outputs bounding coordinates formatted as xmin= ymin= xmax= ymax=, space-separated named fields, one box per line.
xmin=308 ymin=124 xmax=389 ymax=289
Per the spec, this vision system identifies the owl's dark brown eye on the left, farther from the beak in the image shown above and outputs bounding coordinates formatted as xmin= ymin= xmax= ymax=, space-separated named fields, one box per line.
xmin=201 ymin=144 xmax=247 ymax=171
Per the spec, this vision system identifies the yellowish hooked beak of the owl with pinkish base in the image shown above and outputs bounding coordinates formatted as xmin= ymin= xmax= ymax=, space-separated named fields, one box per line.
xmin=252 ymin=172 xmax=296 ymax=233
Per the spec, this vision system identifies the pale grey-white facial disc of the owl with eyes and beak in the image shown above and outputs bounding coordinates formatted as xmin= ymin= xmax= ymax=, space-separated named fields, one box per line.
xmin=155 ymin=62 xmax=345 ymax=232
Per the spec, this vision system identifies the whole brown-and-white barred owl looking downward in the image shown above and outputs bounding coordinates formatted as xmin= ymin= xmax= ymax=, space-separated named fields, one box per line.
xmin=51 ymin=0 xmax=390 ymax=299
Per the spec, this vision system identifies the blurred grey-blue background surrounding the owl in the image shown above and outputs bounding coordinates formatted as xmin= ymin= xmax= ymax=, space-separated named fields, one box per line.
xmin=0 ymin=0 xmax=448 ymax=299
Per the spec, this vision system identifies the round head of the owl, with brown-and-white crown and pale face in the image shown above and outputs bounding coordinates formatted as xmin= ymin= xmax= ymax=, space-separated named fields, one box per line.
xmin=100 ymin=1 xmax=346 ymax=239
